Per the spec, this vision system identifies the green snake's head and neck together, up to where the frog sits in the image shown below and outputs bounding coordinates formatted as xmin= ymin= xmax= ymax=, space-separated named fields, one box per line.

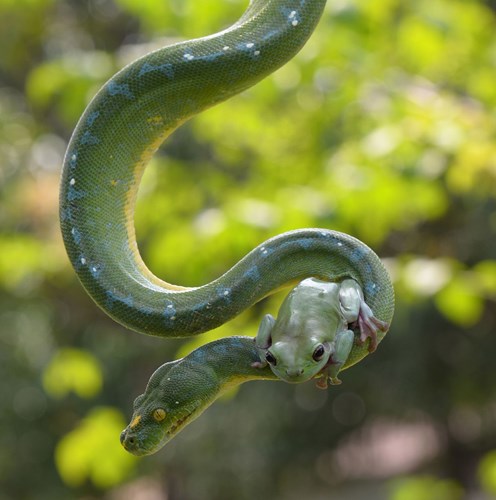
xmin=121 ymin=336 xmax=279 ymax=456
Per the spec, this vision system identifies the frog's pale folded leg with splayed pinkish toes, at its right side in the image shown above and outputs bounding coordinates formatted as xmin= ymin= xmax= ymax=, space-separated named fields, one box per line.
xmin=339 ymin=279 xmax=389 ymax=352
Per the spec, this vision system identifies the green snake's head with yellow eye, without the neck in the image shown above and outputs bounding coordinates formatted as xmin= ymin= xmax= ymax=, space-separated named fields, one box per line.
xmin=120 ymin=360 xmax=218 ymax=456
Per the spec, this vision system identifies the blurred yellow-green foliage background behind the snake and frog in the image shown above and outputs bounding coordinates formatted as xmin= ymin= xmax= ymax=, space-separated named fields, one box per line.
xmin=0 ymin=0 xmax=496 ymax=500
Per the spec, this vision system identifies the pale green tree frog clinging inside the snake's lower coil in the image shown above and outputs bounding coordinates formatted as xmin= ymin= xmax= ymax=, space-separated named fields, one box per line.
xmin=255 ymin=278 xmax=388 ymax=388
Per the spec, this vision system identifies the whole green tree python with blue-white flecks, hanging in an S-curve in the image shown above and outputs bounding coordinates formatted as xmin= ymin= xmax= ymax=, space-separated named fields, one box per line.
xmin=60 ymin=0 xmax=394 ymax=455
